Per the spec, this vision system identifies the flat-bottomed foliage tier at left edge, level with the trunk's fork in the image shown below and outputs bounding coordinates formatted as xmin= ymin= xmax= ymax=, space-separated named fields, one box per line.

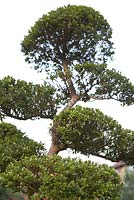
xmin=0 ymin=76 xmax=58 ymax=120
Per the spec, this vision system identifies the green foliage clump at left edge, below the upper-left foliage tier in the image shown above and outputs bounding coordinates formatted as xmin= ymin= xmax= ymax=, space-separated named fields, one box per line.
xmin=0 ymin=122 xmax=45 ymax=172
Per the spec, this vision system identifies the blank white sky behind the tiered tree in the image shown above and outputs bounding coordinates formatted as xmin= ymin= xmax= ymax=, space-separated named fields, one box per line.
xmin=0 ymin=0 xmax=134 ymax=165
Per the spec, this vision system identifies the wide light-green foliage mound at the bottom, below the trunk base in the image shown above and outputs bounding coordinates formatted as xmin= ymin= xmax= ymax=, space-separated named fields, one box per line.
xmin=2 ymin=156 xmax=120 ymax=200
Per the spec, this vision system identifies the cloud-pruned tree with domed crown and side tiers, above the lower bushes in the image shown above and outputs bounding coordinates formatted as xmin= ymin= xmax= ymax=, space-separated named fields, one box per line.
xmin=0 ymin=5 xmax=134 ymax=199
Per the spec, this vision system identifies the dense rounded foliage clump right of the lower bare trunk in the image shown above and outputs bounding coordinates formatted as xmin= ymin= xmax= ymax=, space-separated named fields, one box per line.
xmin=55 ymin=106 xmax=134 ymax=164
